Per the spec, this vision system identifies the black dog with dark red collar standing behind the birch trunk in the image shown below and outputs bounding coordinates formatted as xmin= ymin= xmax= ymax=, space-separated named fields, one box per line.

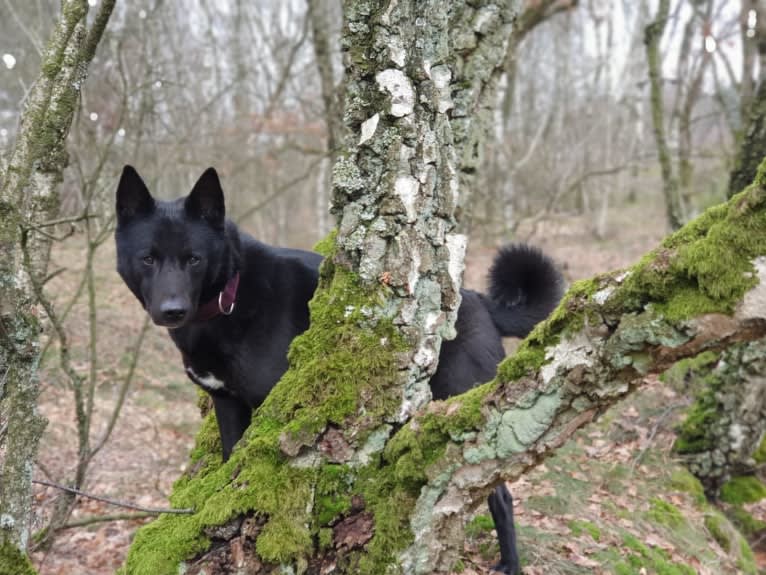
xmin=115 ymin=166 xmax=562 ymax=572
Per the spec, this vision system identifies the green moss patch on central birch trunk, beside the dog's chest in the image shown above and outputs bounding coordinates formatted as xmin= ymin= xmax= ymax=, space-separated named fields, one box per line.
xmin=260 ymin=262 xmax=407 ymax=443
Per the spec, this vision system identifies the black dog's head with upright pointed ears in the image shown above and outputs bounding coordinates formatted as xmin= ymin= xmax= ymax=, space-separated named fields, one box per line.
xmin=115 ymin=166 xmax=231 ymax=328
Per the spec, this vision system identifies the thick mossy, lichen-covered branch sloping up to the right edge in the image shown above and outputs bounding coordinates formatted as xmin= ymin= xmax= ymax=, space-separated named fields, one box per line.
xmin=385 ymin=176 xmax=766 ymax=566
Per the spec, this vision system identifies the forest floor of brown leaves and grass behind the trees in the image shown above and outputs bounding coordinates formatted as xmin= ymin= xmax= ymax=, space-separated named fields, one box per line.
xmin=33 ymin=200 xmax=766 ymax=575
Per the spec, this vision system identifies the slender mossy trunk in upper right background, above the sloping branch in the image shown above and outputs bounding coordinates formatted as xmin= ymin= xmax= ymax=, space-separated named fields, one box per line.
xmin=644 ymin=0 xmax=683 ymax=230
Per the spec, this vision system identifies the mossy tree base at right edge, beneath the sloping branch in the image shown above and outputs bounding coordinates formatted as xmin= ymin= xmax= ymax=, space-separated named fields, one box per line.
xmin=676 ymin=338 xmax=766 ymax=497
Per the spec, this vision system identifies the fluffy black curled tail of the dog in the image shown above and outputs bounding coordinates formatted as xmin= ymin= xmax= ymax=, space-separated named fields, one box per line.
xmin=483 ymin=244 xmax=564 ymax=337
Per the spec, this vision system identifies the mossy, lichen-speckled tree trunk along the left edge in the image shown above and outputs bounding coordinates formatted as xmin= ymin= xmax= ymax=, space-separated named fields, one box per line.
xmin=0 ymin=0 xmax=114 ymax=573
